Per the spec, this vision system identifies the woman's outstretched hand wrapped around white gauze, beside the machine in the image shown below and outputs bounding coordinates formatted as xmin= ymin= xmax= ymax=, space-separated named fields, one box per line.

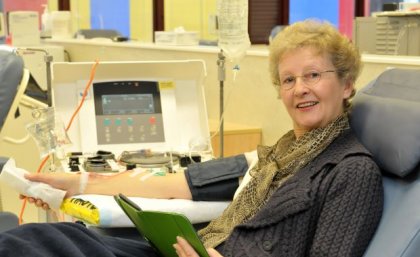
xmin=19 ymin=173 xmax=80 ymax=210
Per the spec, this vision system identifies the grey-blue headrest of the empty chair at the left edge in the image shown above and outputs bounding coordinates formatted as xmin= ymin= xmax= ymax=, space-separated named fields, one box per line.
xmin=0 ymin=48 xmax=24 ymax=130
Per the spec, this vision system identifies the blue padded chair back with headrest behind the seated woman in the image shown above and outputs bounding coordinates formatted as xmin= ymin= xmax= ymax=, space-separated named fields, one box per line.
xmin=350 ymin=69 xmax=420 ymax=257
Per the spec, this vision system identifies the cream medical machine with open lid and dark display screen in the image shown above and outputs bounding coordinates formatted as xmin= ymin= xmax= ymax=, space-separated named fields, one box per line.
xmin=52 ymin=60 xmax=212 ymax=171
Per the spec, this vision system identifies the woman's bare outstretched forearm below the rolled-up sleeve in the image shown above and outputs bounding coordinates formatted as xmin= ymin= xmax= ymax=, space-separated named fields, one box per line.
xmin=83 ymin=171 xmax=192 ymax=199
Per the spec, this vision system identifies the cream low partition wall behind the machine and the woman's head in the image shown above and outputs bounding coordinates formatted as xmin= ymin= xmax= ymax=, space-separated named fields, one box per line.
xmin=43 ymin=40 xmax=420 ymax=144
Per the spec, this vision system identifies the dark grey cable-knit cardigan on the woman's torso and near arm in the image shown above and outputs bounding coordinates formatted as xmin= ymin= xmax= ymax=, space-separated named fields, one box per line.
xmin=217 ymin=130 xmax=383 ymax=257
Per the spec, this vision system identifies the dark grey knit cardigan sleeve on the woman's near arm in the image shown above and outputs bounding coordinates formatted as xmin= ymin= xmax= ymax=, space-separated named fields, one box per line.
xmin=309 ymin=156 xmax=383 ymax=257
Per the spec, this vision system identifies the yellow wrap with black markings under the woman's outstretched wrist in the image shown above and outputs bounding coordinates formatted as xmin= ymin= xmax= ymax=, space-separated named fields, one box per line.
xmin=60 ymin=198 xmax=100 ymax=225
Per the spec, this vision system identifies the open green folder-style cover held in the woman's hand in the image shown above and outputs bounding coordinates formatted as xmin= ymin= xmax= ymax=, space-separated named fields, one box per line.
xmin=114 ymin=194 xmax=209 ymax=257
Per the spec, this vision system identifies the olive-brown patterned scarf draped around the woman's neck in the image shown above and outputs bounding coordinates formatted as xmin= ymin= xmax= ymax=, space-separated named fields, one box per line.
xmin=199 ymin=114 xmax=349 ymax=247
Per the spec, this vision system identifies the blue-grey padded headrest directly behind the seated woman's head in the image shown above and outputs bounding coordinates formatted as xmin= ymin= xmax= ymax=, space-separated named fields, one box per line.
xmin=350 ymin=69 xmax=420 ymax=177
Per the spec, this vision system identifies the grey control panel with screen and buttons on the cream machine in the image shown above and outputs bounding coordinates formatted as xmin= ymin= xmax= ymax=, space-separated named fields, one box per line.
xmin=93 ymin=81 xmax=165 ymax=145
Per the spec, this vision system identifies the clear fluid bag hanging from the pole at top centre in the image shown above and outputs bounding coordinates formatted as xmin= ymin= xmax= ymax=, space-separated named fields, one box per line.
xmin=217 ymin=0 xmax=251 ymax=63
